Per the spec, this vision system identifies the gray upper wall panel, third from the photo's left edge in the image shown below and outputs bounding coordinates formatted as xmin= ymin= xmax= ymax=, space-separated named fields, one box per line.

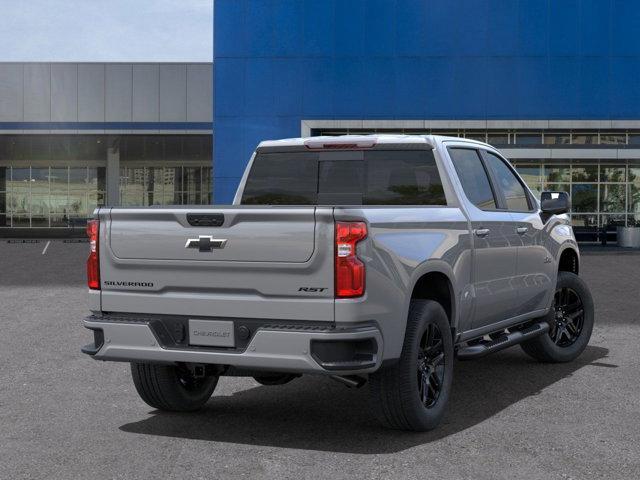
xmin=51 ymin=63 xmax=78 ymax=122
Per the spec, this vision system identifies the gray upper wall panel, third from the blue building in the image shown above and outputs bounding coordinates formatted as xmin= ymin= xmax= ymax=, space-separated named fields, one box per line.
xmin=133 ymin=64 xmax=160 ymax=122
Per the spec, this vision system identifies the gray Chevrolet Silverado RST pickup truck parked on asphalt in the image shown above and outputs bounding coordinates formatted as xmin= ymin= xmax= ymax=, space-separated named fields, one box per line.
xmin=83 ymin=135 xmax=594 ymax=430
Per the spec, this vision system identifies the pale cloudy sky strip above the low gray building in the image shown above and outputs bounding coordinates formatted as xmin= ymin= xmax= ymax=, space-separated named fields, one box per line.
xmin=0 ymin=0 xmax=214 ymax=62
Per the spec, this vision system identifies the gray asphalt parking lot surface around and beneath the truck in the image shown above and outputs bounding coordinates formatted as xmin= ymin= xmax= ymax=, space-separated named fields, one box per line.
xmin=0 ymin=240 xmax=640 ymax=480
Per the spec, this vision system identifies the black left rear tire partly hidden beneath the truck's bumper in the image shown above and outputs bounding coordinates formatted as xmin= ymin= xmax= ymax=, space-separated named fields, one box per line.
xmin=131 ymin=363 xmax=219 ymax=412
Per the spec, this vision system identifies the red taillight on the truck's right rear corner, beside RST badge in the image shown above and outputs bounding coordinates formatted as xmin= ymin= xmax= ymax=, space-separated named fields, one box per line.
xmin=335 ymin=222 xmax=367 ymax=298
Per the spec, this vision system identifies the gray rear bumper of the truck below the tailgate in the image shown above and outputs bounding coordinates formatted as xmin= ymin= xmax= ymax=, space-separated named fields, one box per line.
xmin=82 ymin=317 xmax=383 ymax=375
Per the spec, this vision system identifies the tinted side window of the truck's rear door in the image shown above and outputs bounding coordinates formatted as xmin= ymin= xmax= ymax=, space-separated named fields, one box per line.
xmin=449 ymin=148 xmax=497 ymax=210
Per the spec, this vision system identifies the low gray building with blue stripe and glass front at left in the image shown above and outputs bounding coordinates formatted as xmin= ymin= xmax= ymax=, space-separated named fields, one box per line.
xmin=0 ymin=63 xmax=213 ymax=236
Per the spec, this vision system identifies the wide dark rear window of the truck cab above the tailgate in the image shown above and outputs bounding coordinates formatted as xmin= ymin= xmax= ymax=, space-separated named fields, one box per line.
xmin=242 ymin=150 xmax=447 ymax=205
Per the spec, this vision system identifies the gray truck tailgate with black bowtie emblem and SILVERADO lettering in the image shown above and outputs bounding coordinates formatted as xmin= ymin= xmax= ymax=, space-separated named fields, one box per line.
xmin=99 ymin=206 xmax=334 ymax=322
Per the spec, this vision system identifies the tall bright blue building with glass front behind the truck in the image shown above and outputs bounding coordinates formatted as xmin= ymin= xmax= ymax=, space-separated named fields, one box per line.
xmin=213 ymin=0 xmax=640 ymax=239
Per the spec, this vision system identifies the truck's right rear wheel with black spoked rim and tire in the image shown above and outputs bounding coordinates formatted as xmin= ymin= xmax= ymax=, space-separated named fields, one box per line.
xmin=369 ymin=300 xmax=454 ymax=432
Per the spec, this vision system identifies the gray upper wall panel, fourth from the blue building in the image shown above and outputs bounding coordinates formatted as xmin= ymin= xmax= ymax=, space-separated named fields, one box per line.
xmin=105 ymin=64 xmax=133 ymax=122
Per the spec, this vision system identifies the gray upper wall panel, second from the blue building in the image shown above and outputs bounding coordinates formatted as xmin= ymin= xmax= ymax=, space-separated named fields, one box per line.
xmin=160 ymin=64 xmax=187 ymax=122
